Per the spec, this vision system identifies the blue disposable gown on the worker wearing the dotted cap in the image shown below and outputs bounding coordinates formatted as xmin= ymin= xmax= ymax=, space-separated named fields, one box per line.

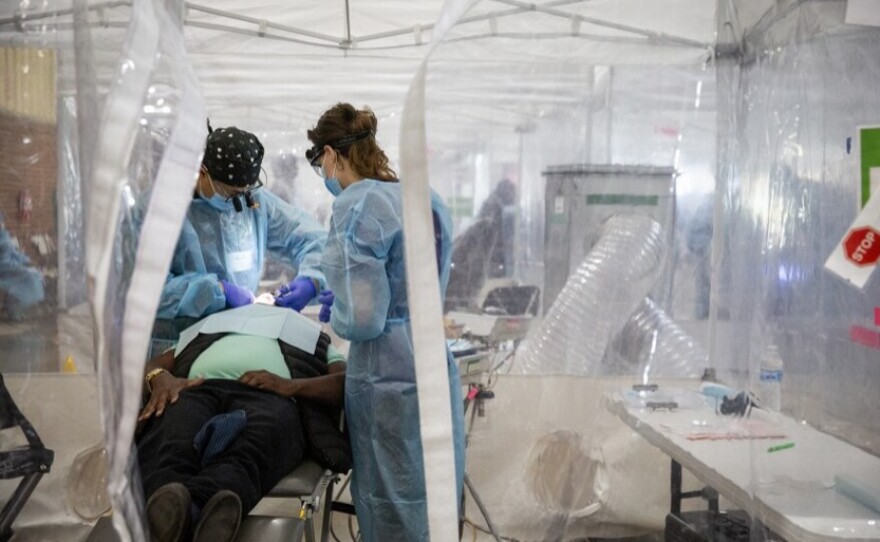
xmin=157 ymin=190 xmax=327 ymax=319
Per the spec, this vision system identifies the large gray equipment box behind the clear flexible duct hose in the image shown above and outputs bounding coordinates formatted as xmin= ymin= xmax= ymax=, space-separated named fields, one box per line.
xmin=543 ymin=164 xmax=676 ymax=314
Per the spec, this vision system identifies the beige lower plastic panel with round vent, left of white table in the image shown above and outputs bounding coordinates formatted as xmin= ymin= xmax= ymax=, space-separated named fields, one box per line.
xmin=465 ymin=374 xmax=669 ymax=540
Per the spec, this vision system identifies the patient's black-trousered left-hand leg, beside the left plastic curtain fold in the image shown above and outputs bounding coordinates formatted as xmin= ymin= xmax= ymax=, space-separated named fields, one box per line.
xmin=138 ymin=380 xmax=225 ymax=498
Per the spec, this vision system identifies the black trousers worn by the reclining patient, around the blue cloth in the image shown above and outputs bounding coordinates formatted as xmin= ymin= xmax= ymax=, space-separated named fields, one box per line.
xmin=137 ymin=380 xmax=305 ymax=513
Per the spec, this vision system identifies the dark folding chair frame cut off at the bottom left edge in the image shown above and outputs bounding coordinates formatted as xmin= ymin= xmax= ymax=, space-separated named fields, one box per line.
xmin=0 ymin=374 xmax=55 ymax=542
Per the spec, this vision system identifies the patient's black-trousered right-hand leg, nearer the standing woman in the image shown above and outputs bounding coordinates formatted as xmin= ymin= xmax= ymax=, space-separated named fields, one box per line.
xmin=185 ymin=381 xmax=305 ymax=514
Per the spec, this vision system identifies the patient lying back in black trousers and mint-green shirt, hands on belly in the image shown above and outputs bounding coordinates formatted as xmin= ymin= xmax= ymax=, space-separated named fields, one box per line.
xmin=136 ymin=307 xmax=351 ymax=542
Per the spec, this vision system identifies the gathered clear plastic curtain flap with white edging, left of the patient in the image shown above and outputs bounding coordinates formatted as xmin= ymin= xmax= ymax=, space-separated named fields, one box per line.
xmin=87 ymin=2 xmax=206 ymax=540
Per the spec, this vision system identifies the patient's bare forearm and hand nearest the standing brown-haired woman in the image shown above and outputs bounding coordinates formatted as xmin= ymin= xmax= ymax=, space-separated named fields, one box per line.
xmin=238 ymin=361 xmax=345 ymax=407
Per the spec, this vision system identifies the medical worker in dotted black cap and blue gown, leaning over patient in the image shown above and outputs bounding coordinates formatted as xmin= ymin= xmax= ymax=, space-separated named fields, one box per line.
xmin=157 ymin=127 xmax=327 ymax=319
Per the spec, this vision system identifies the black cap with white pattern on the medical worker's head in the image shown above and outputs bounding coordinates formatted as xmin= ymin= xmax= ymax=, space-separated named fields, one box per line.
xmin=202 ymin=126 xmax=263 ymax=187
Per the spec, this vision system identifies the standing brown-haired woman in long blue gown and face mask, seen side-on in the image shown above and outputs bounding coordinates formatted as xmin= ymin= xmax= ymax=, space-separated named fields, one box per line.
xmin=306 ymin=104 xmax=464 ymax=542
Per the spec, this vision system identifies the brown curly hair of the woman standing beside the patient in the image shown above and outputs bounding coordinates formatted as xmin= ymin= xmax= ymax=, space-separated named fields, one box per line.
xmin=307 ymin=103 xmax=397 ymax=182
